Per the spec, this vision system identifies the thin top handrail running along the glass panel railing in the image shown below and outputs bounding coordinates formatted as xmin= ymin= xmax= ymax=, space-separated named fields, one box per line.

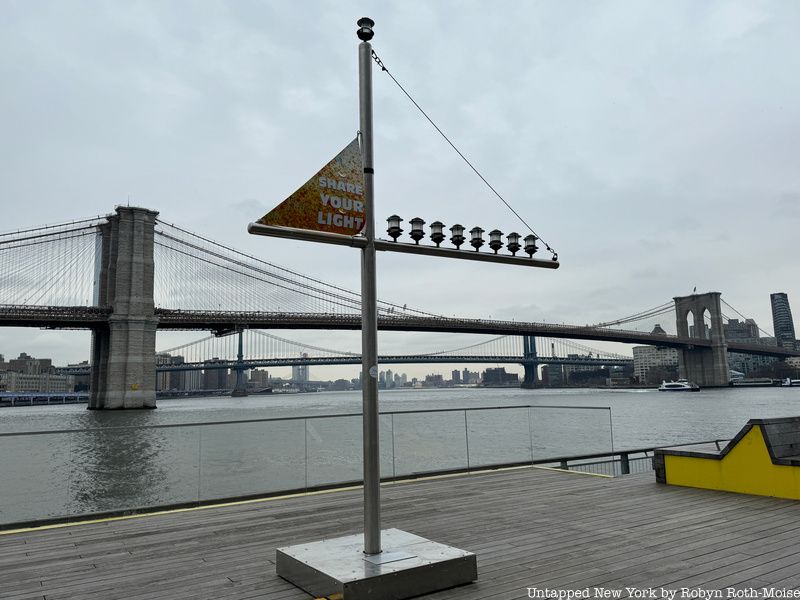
xmin=0 ymin=404 xmax=611 ymax=437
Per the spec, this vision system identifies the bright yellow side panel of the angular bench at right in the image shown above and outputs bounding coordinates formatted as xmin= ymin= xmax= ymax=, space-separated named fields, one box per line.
xmin=664 ymin=425 xmax=800 ymax=500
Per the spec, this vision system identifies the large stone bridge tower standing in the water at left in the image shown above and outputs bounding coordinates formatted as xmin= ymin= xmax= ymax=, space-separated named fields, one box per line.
xmin=89 ymin=206 xmax=158 ymax=409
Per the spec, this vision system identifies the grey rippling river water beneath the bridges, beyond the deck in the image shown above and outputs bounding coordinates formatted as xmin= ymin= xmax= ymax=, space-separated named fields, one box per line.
xmin=0 ymin=387 xmax=800 ymax=524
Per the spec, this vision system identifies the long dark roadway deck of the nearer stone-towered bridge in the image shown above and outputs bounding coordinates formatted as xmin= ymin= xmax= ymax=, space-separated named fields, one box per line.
xmin=0 ymin=305 xmax=800 ymax=358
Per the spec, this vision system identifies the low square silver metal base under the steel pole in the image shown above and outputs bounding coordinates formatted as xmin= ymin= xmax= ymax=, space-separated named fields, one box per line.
xmin=276 ymin=529 xmax=478 ymax=600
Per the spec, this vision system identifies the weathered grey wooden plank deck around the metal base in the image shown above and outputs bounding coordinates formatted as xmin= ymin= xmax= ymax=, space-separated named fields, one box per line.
xmin=0 ymin=469 xmax=800 ymax=600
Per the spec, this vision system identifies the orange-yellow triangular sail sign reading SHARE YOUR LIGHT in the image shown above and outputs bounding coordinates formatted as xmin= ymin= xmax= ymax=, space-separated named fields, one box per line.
xmin=258 ymin=138 xmax=367 ymax=235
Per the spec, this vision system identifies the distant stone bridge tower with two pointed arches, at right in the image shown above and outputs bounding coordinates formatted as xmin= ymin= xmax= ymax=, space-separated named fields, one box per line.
xmin=674 ymin=292 xmax=730 ymax=387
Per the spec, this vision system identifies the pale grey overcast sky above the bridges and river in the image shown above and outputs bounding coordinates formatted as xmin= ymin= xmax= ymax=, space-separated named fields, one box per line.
xmin=0 ymin=0 xmax=800 ymax=372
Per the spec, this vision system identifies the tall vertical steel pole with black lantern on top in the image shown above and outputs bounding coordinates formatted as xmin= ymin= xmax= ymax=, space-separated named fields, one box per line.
xmin=358 ymin=17 xmax=381 ymax=554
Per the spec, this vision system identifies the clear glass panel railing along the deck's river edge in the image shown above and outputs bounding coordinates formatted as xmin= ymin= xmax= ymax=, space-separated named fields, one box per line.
xmin=0 ymin=406 xmax=614 ymax=526
